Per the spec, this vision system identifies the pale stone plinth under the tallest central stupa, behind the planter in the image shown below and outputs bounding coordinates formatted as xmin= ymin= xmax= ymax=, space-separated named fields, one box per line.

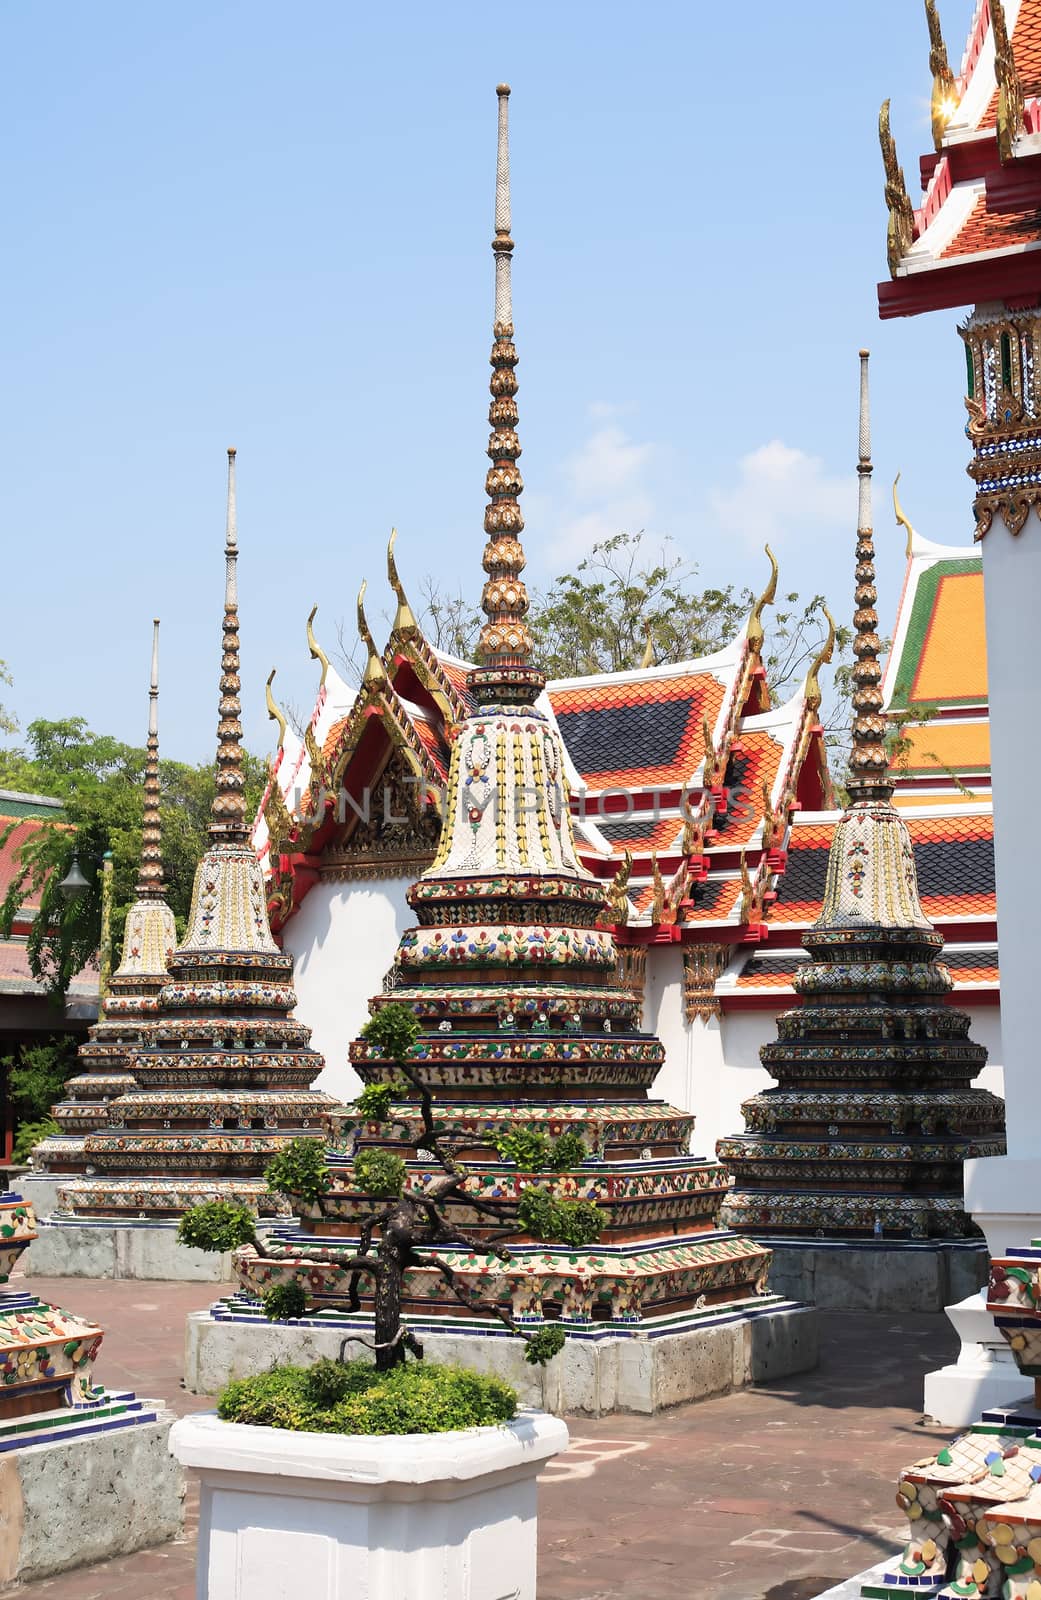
xmin=184 ymin=1296 xmax=817 ymax=1416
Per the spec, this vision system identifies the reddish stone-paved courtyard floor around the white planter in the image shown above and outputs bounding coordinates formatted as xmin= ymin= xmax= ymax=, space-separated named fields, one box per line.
xmin=18 ymin=1278 xmax=956 ymax=1600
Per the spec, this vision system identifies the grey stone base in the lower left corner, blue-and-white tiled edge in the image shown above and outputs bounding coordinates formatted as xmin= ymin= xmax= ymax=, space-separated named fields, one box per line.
xmin=0 ymin=1395 xmax=184 ymax=1587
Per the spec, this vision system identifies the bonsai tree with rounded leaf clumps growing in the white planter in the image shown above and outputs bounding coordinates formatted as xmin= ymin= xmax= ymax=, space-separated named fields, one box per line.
xmin=179 ymin=1003 xmax=601 ymax=1371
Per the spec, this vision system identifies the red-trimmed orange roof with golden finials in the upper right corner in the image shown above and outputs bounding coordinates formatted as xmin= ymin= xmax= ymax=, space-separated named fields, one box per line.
xmin=878 ymin=0 xmax=1041 ymax=317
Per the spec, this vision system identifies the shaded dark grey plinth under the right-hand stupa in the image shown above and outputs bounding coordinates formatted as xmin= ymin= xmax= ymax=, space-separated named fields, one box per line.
xmin=763 ymin=1238 xmax=988 ymax=1312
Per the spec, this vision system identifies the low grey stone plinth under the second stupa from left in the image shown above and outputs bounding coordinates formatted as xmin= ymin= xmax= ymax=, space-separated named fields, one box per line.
xmin=22 ymin=1219 xmax=235 ymax=1283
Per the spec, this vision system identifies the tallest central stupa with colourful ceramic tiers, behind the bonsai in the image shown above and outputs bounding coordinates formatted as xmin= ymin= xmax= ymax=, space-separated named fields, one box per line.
xmin=228 ymin=85 xmax=812 ymax=1369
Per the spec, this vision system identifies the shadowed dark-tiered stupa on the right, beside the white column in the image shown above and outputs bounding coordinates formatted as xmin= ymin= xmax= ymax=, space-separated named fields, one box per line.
xmin=716 ymin=350 xmax=1004 ymax=1261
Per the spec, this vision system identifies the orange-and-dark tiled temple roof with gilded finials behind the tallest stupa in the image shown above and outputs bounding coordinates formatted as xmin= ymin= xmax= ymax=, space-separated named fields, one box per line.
xmin=253 ymin=570 xmax=827 ymax=938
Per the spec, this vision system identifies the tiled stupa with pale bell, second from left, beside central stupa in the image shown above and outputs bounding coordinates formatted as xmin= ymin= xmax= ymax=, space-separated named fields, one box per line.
xmin=56 ymin=450 xmax=334 ymax=1221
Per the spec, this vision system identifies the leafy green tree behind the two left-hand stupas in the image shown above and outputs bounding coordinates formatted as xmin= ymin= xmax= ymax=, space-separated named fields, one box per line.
xmin=0 ymin=717 xmax=267 ymax=997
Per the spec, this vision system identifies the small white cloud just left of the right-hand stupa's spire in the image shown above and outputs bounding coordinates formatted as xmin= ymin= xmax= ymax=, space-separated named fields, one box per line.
xmin=708 ymin=438 xmax=857 ymax=547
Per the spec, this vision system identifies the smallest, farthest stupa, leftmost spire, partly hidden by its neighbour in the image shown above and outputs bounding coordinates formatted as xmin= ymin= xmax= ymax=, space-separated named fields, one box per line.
xmin=34 ymin=621 xmax=177 ymax=1173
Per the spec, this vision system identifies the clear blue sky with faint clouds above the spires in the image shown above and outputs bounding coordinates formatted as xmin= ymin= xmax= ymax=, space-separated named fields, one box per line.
xmin=0 ymin=0 xmax=972 ymax=760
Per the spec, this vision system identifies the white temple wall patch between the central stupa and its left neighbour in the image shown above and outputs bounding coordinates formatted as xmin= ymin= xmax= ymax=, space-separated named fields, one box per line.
xmin=285 ymin=878 xmax=414 ymax=1101
